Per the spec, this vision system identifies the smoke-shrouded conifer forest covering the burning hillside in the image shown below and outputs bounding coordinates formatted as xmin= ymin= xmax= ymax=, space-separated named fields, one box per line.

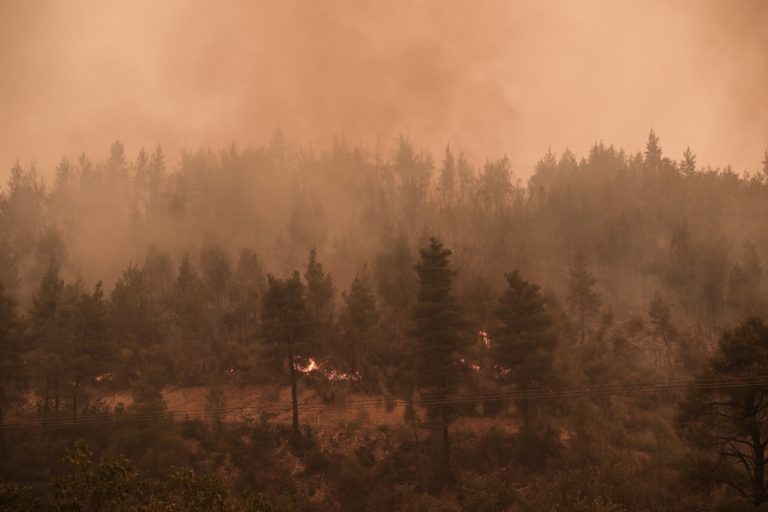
xmin=0 ymin=130 xmax=768 ymax=512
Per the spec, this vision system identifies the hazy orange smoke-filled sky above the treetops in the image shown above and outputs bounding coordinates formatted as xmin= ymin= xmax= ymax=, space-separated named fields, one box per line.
xmin=0 ymin=0 xmax=768 ymax=178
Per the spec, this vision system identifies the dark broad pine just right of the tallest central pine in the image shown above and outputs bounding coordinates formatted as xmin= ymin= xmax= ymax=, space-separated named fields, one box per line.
xmin=491 ymin=270 xmax=557 ymax=430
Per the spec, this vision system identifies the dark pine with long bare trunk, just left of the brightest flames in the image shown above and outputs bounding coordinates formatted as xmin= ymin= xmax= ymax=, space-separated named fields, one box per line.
xmin=261 ymin=272 xmax=310 ymax=437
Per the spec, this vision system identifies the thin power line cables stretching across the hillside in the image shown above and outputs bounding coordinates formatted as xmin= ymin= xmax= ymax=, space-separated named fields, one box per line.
xmin=2 ymin=376 xmax=768 ymax=429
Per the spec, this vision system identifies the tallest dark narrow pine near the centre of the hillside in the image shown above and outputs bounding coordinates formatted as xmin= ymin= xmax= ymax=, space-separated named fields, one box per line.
xmin=410 ymin=237 xmax=471 ymax=465
